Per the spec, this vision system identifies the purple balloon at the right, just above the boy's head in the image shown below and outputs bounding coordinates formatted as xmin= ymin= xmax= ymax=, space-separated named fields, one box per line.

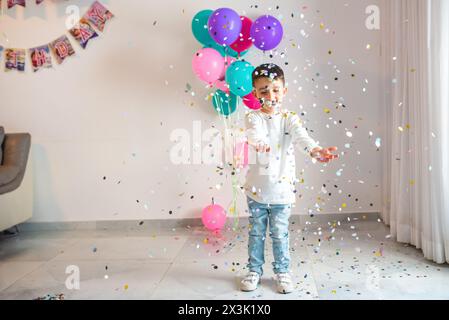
xmin=250 ymin=15 xmax=284 ymax=51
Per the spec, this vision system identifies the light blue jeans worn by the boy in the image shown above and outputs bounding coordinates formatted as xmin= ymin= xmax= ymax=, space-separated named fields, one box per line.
xmin=247 ymin=197 xmax=291 ymax=275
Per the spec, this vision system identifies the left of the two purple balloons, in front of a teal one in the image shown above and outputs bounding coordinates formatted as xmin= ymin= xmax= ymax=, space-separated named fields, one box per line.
xmin=208 ymin=8 xmax=242 ymax=46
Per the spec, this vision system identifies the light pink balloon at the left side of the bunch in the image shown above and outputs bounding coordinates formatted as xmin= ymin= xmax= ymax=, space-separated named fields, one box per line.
xmin=192 ymin=48 xmax=225 ymax=84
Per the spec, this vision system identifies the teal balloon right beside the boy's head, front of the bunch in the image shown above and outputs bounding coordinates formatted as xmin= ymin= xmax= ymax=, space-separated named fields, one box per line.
xmin=226 ymin=61 xmax=254 ymax=97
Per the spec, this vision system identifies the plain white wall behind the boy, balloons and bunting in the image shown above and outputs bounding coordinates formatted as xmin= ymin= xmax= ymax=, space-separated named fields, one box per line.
xmin=0 ymin=0 xmax=382 ymax=222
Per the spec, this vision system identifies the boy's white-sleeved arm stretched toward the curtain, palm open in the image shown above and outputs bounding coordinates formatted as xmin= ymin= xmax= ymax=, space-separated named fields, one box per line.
xmin=288 ymin=114 xmax=338 ymax=163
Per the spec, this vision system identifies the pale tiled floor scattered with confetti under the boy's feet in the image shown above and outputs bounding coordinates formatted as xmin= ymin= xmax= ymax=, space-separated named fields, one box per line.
xmin=0 ymin=220 xmax=449 ymax=300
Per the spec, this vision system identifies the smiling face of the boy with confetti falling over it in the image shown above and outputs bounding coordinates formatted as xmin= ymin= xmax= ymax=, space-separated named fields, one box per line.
xmin=253 ymin=77 xmax=287 ymax=113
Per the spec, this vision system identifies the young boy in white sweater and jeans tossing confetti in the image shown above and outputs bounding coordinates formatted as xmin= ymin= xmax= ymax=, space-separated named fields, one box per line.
xmin=241 ymin=64 xmax=338 ymax=293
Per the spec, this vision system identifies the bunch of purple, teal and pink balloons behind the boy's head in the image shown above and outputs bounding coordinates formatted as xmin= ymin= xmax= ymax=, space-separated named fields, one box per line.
xmin=192 ymin=8 xmax=283 ymax=116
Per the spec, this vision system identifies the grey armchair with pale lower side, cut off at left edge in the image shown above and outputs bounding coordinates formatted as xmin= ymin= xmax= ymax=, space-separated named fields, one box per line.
xmin=0 ymin=127 xmax=32 ymax=231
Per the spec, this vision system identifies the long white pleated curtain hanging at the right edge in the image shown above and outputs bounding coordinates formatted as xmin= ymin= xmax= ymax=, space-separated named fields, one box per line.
xmin=381 ymin=0 xmax=449 ymax=263
